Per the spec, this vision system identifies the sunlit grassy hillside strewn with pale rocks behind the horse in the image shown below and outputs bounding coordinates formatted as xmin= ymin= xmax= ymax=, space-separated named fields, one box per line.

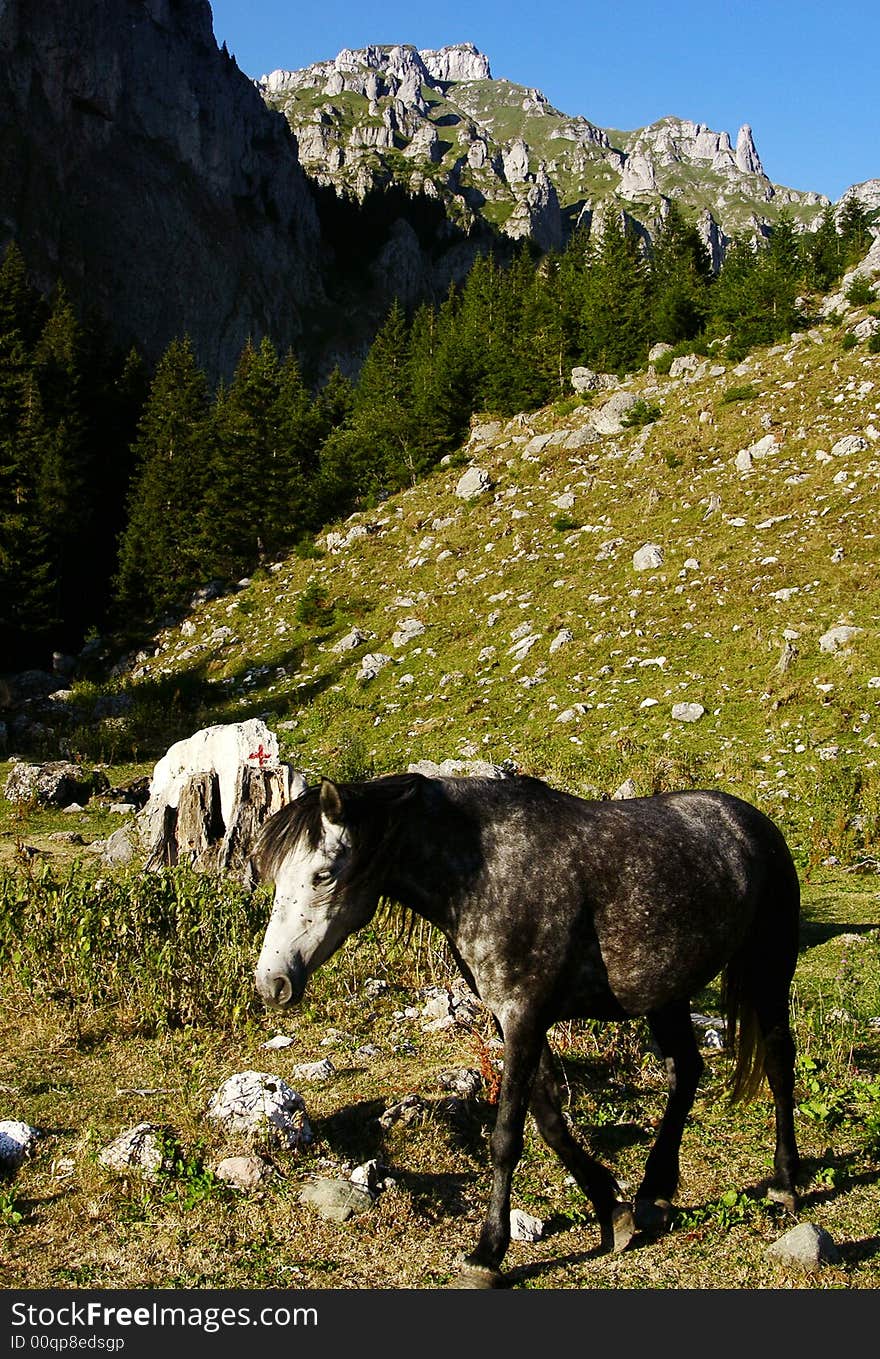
xmin=91 ymin=312 xmax=880 ymax=862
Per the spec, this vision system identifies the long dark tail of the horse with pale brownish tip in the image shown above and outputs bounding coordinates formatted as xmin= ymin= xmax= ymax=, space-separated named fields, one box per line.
xmin=722 ymin=826 xmax=800 ymax=1101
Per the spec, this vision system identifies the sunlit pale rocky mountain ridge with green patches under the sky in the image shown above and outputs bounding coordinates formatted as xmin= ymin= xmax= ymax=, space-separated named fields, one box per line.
xmin=255 ymin=42 xmax=830 ymax=266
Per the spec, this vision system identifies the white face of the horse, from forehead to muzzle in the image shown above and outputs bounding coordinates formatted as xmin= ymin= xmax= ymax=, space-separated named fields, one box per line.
xmin=257 ymin=817 xmax=350 ymax=1003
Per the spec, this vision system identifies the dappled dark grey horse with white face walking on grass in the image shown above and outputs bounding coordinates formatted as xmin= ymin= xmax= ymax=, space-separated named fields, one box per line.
xmin=254 ymin=773 xmax=800 ymax=1287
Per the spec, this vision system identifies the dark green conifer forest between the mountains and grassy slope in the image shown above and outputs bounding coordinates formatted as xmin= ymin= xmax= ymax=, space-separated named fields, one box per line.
xmin=0 ymin=200 xmax=870 ymax=670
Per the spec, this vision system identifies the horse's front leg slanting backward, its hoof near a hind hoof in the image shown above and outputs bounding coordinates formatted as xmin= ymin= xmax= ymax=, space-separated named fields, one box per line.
xmin=530 ymin=1042 xmax=636 ymax=1250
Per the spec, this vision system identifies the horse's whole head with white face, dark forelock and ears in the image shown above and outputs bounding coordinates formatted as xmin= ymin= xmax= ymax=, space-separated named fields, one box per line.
xmin=255 ymin=779 xmax=379 ymax=1008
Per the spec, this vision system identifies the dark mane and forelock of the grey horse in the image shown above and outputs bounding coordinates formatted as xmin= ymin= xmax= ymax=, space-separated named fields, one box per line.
xmin=251 ymin=773 xmax=424 ymax=882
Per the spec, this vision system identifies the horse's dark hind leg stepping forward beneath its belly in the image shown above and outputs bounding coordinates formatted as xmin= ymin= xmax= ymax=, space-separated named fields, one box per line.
xmin=636 ymin=1002 xmax=703 ymax=1231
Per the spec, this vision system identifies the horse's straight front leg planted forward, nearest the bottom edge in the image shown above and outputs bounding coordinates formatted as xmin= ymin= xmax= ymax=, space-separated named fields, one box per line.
xmin=451 ymin=1021 xmax=543 ymax=1288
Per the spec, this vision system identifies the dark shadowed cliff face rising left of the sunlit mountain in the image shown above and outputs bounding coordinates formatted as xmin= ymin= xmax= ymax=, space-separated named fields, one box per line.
xmin=0 ymin=0 xmax=320 ymax=375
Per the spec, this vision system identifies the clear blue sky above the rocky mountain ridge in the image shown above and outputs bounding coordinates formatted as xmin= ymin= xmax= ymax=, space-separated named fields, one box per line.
xmin=210 ymin=0 xmax=880 ymax=200
